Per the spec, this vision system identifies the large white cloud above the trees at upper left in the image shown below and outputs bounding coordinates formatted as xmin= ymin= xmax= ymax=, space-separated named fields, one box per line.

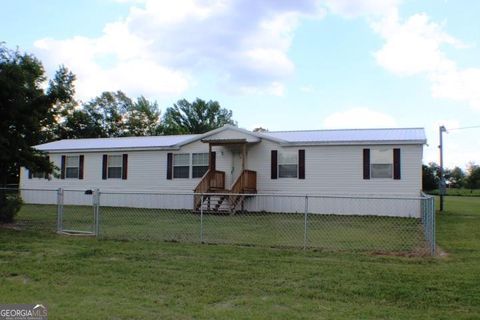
xmin=34 ymin=24 xmax=189 ymax=100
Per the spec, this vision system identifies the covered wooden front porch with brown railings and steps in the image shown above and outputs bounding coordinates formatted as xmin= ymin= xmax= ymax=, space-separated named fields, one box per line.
xmin=194 ymin=139 xmax=257 ymax=213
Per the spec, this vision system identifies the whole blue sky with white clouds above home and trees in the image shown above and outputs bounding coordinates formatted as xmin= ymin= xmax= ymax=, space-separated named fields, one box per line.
xmin=0 ymin=0 xmax=480 ymax=167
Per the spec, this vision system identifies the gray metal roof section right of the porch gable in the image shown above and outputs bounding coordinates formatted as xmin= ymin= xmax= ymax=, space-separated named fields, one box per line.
xmin=262 ymin=128 xmax=426 ymax=144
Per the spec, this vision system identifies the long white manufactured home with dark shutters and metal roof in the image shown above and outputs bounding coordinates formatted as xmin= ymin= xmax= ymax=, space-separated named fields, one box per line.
xmin=20 ymin=125 xmax=426 ymax=216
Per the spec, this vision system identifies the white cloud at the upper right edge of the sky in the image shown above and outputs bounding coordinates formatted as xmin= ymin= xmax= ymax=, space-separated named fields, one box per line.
xmin=371 ymin=11 xmax=480 ymax=110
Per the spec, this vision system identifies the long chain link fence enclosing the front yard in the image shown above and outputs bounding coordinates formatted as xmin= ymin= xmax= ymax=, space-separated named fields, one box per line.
xmin=0 ymin=189 xmax=435 ymax=255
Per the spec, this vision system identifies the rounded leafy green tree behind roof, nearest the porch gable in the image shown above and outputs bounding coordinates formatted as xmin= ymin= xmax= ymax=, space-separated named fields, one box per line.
xmin=163 ymin=98 xmax=236 ymax=134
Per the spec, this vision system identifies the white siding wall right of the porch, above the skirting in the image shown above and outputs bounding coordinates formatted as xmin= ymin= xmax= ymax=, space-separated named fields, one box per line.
xmin=248 ymin=141 xmax=422 ymax=197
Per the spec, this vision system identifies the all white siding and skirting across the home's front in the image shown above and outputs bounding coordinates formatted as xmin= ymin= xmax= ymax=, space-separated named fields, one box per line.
xmin=20 ymin=132 xmax=422 ymax=216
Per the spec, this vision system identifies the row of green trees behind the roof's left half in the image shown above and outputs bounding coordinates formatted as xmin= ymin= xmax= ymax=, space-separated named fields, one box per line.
xmin=53 ymin=91 xmax=236 ymax=140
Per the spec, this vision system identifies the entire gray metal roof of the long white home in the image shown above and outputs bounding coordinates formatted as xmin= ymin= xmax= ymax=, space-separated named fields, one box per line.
xmin=35 ymin=126 xmax=426 ymax=152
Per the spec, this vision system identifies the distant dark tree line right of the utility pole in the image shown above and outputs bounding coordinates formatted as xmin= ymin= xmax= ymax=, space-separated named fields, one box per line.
xmin=422 ymin=162 xmax=480 ymax=191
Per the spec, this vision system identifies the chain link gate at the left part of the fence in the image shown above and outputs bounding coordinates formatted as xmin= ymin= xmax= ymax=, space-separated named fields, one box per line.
xmin=57 ymin=188 xmax=100 ymax=236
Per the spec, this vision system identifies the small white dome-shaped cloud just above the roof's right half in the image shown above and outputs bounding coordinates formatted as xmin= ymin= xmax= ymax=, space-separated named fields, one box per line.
xmin=323 ymin=107 xmax=397 ymax=129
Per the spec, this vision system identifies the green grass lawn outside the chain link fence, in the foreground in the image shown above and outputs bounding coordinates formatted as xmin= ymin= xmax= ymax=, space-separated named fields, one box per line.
xmin=0 ymin=197 xmax=480 ymax=319
